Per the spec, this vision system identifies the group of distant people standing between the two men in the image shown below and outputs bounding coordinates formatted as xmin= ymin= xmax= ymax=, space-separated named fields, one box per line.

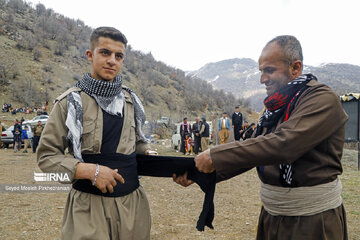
xmin=180 ymin=106 xmax=256 ymax=155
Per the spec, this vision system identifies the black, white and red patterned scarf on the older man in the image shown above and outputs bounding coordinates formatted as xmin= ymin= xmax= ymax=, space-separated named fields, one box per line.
xmin=255 ymin=74 xmax=317 ymax=186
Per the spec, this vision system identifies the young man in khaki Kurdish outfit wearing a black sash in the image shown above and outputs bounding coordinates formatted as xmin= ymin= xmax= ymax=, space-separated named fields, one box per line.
xmin=37 ymin=27 xmax=157 ymax=240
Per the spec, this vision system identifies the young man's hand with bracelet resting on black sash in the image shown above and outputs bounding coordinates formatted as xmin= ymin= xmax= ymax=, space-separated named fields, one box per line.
xmin=91 ymin=165 xmax=125 ymax=193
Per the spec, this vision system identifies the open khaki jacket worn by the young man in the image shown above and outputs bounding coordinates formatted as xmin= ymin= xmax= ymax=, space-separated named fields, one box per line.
xmin=37 ymin=87 xmax=150 ymax=181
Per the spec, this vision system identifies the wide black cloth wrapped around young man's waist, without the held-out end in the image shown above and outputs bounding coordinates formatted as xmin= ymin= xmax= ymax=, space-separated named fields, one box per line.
xmin=72 ymin=153 xmax=139 ymax=197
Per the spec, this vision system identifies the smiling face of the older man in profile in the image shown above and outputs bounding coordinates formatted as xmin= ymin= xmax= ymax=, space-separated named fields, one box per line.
xmin=259 ymin=42 xmax=292 ymax=96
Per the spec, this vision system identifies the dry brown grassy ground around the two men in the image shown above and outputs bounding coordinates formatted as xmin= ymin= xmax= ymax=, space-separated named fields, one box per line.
xmin=0 ymin=142 xmax=360 ymax=240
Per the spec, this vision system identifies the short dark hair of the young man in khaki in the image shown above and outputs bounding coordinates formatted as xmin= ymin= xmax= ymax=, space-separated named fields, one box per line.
xmin=90 ymin=27 xmax=127 ymax=50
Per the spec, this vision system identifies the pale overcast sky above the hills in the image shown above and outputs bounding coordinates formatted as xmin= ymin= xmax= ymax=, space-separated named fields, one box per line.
xmin=26 ymin=0 xmax=360 ymax=70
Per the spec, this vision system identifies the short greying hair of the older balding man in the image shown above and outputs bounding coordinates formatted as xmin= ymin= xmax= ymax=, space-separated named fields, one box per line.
xmin=266 ymin=35 xmax=303 ymax=65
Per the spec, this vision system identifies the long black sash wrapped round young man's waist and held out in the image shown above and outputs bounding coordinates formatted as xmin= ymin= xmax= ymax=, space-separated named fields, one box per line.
xmin=73 ymin=153 xmax=216 ymax=231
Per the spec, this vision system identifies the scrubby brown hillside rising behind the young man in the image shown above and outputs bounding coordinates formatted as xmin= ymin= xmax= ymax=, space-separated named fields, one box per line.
xmin=0 ymin=0 xmax=250 ymax=121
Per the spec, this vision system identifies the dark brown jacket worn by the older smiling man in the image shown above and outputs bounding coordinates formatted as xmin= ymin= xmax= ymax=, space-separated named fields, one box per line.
xmin=210 ymin=81 xmax=347 ymax=186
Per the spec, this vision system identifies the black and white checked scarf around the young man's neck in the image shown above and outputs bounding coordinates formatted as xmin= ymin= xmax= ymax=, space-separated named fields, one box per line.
xmin=65 ymin=73 xmax=149 ymax=162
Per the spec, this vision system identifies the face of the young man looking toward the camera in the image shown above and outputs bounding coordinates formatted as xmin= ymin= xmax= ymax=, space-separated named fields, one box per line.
xmin=86 ymin=37 xmax=125 ymax=82
